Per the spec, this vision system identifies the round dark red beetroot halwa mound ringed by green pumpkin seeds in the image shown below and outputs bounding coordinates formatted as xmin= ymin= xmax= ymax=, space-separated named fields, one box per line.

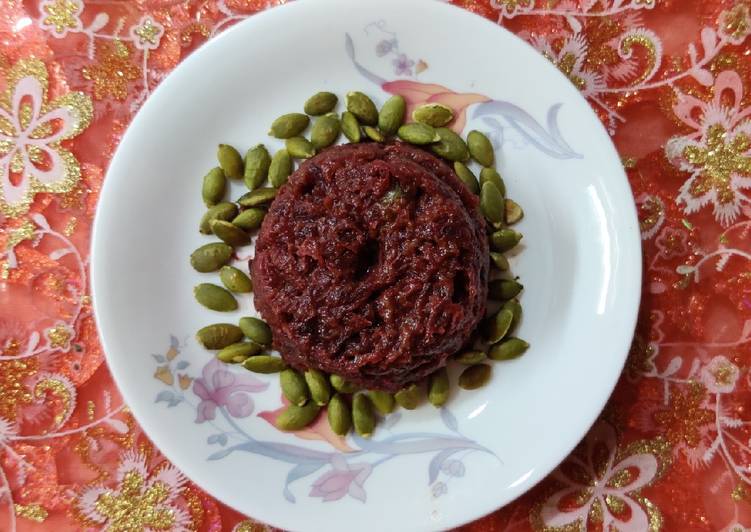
xmin=251 ymin=143 xmax=489 ymax=392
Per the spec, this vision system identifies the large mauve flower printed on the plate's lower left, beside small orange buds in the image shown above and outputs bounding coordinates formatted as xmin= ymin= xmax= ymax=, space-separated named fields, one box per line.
xmin=193 ymin=359 xmax=269 ymax=423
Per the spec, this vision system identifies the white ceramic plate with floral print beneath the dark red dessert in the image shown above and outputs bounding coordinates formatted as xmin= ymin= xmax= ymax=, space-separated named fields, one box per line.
xmin=92 ymin=0 xmax=641 ymax=531
